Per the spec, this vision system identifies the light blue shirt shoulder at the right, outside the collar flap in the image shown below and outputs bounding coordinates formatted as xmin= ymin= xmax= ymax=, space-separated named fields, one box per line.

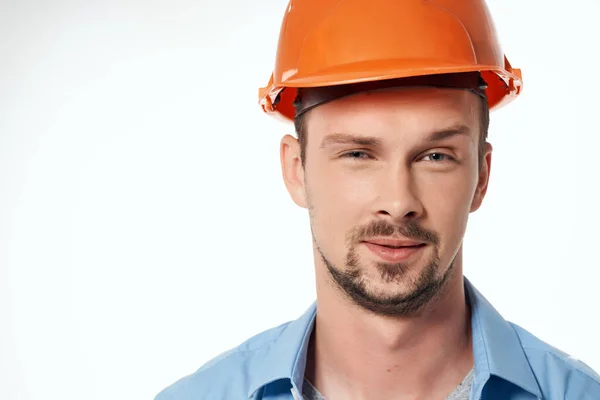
xmin=510 ymin=322 xmax=600 ymax=399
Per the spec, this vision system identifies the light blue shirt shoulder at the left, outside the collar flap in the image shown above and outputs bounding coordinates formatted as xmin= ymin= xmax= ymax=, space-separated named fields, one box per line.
xmin=154 ymin=322 xmax=290 ymax=400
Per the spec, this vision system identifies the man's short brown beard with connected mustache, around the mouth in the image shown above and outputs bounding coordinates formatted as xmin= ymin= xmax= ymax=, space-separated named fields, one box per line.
xmin=313 ymin=220 xmax=454 ymax=317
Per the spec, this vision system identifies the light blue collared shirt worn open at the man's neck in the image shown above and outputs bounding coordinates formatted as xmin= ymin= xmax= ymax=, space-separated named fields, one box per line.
xmin=155 ymin=278 xmax=600 ymax=400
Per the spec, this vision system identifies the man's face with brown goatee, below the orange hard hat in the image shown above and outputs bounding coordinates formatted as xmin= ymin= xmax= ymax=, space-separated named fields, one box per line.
xmin=282 ymin=88 xmax=491 ymax=315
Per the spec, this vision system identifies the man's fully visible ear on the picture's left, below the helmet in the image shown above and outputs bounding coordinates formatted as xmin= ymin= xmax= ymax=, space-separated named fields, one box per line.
xmin=280 ymin=135 xmax=308 ymax=208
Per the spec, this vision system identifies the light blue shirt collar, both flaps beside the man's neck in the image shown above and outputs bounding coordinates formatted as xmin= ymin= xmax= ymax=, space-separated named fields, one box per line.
xmin=248 ymin=278 xmax=542 ymax=398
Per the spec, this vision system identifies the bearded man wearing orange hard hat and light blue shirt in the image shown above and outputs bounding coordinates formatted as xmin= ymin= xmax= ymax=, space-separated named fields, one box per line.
xmin=157 ymin=0 xmax=600 ymax=400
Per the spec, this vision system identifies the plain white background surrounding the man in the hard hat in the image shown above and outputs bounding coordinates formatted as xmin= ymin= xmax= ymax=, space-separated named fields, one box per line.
xmin=0 ymin=0 xmax=600 ymax=400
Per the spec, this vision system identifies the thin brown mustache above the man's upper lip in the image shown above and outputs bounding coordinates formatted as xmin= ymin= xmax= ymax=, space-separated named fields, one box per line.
xmin=347 ymin=220 xmax=440 ymax=245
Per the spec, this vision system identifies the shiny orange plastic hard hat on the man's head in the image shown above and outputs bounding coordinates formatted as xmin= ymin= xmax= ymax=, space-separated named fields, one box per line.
xmin=259 ymin=0 xmax=523 ymax=120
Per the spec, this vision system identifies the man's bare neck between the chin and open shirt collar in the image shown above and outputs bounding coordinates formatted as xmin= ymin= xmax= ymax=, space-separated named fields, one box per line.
xmin=306 ymin=260 xmax=473 ymax=400
